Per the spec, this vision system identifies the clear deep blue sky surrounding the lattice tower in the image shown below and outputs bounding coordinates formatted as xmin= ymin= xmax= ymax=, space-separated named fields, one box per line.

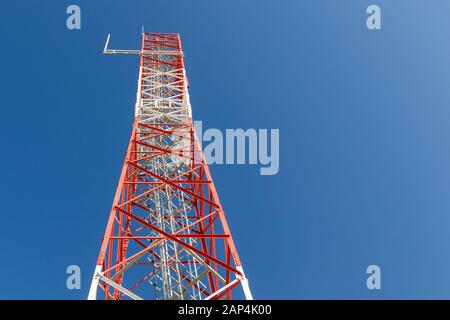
xmin=0 ymin=0 xmax=450 ymax=299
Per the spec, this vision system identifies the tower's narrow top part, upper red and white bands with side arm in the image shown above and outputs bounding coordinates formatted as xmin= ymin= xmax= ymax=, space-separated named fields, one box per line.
xmin=103 ymin=32 xmax=192 ymax=123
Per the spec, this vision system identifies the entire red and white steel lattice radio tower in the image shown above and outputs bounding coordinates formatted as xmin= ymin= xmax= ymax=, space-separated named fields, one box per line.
xmin=88 ymin=31 xmax=252 ymax=300
